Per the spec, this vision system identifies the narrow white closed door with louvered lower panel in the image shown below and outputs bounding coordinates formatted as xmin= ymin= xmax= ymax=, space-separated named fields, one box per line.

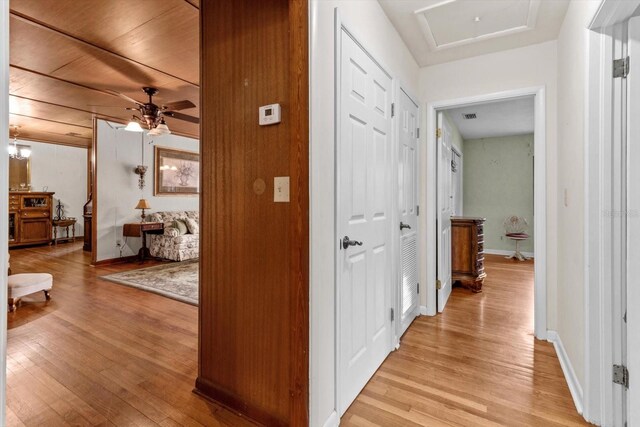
xmin=398 ymin=89 xmax=419 ymax=336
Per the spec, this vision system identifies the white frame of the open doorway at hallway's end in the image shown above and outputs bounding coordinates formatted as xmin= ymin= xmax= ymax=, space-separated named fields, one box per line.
xmin=420 ymin=86 xmax=547 ymax=340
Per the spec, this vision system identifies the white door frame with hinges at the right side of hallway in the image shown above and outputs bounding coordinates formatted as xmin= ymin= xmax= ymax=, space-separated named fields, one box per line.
xmin=583 ymin=0 xmax=640 ymax=426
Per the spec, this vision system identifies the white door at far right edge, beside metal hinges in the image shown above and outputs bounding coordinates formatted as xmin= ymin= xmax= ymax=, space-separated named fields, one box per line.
xmin=614 ymin=17 xmax=640 ymax=427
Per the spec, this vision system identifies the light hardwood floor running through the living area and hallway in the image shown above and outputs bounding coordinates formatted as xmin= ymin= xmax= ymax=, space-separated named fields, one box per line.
xmin=7 ymin=243 xmax=585 ymax=426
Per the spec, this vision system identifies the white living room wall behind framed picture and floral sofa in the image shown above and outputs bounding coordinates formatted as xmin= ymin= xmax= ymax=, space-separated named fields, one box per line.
xmin=95 ymin=120 xmax=199 ymax=261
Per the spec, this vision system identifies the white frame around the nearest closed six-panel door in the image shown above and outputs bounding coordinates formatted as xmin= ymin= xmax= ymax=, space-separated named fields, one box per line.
xmin=332 ymin=8 xmax=398 ymax=419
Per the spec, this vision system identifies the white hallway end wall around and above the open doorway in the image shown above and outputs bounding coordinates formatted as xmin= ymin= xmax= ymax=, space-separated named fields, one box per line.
xmin=420 ymin=41 xmax=556 ymax=328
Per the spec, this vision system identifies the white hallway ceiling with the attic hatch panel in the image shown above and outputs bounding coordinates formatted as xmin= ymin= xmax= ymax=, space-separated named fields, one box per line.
xmin=378 ymin=0 xmax=569 ymax=67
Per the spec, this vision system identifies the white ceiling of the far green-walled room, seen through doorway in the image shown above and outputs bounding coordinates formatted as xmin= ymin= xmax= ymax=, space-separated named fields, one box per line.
xmin=447 ymin=96 xmax=534 ymax=140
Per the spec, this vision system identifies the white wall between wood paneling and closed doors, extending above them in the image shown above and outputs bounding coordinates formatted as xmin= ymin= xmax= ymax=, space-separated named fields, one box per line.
xmin=310 ymin=0 xmax=419 ymax=426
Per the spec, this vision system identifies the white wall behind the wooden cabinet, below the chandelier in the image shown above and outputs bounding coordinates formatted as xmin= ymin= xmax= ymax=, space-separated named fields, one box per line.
xmin=18 ymin=140 xmax=88 ymax=237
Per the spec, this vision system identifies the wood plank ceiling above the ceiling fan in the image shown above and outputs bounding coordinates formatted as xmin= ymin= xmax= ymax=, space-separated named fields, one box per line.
xmin=9 ymin=0 xmax=200 ymax=147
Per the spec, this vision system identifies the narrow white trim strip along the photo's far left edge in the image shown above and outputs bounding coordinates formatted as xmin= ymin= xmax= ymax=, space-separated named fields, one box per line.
xmin=0 ymin=1 xmax=9 ymax=425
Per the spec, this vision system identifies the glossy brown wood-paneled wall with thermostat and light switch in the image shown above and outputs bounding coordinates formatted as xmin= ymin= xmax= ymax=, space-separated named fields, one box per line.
xmin=195 ymin=0 xmax=308 ymax=425
